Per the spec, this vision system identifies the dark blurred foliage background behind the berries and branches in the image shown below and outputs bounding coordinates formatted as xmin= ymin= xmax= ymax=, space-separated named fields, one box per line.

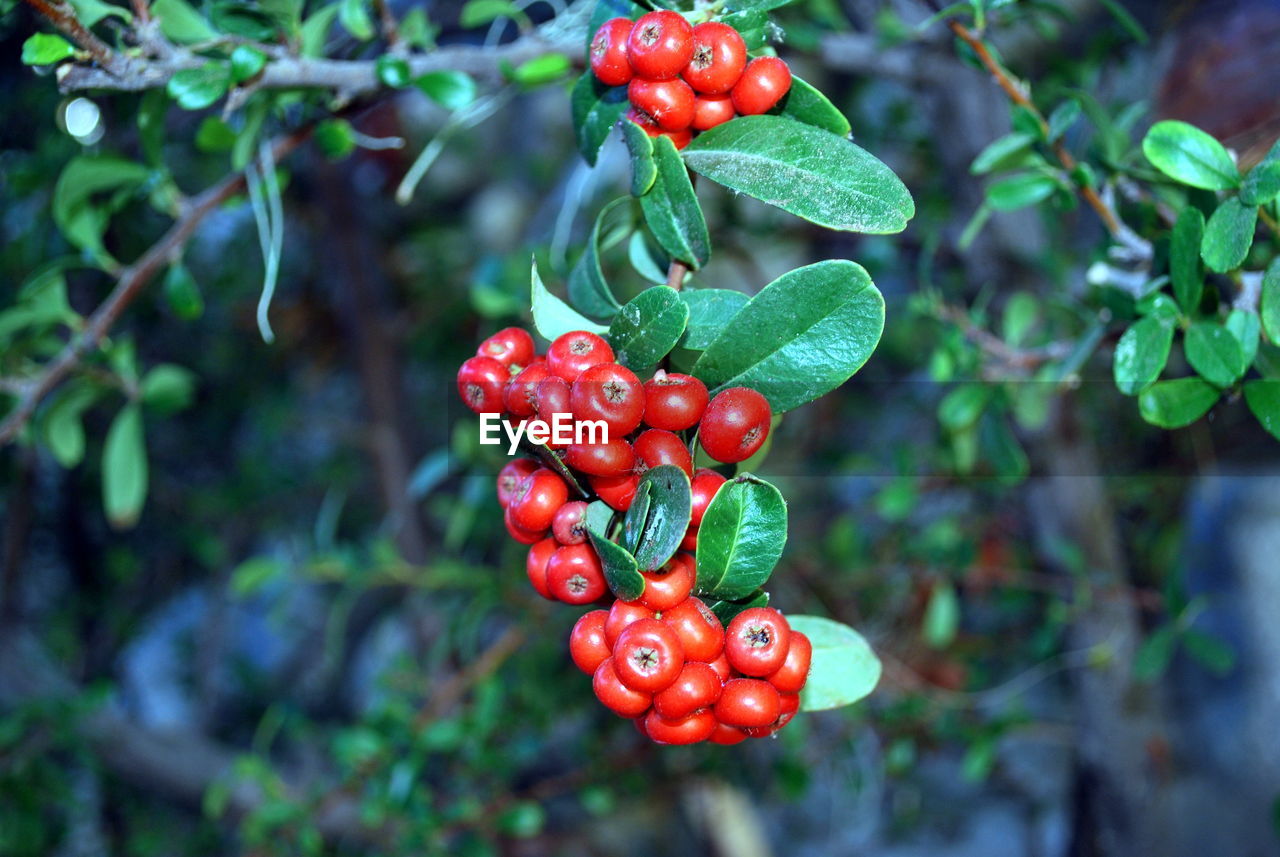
xmin=0 ymin=0 xmax=1280 ymax=857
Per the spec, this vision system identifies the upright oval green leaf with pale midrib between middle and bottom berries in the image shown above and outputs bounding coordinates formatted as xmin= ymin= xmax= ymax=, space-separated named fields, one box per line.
xmin=696 ymin=475 xmax=787 ymax=599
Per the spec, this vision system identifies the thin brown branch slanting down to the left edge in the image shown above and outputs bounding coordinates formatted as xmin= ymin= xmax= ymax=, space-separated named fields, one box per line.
xmin=0 ymin=127 xmax=311 ymax=446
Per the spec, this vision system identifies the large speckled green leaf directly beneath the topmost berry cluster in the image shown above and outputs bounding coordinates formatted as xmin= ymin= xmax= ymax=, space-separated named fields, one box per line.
xmin=685 ymin=116 xmax=915 ymax=234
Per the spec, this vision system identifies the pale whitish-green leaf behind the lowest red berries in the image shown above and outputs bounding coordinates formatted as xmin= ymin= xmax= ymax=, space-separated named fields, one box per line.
xmin=787 ymin=615 xmax=881 ymax=711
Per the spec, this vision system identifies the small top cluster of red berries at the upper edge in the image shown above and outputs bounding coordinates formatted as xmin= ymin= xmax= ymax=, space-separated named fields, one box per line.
xmin=589 ymin=9 xmax=791 ymax=148
